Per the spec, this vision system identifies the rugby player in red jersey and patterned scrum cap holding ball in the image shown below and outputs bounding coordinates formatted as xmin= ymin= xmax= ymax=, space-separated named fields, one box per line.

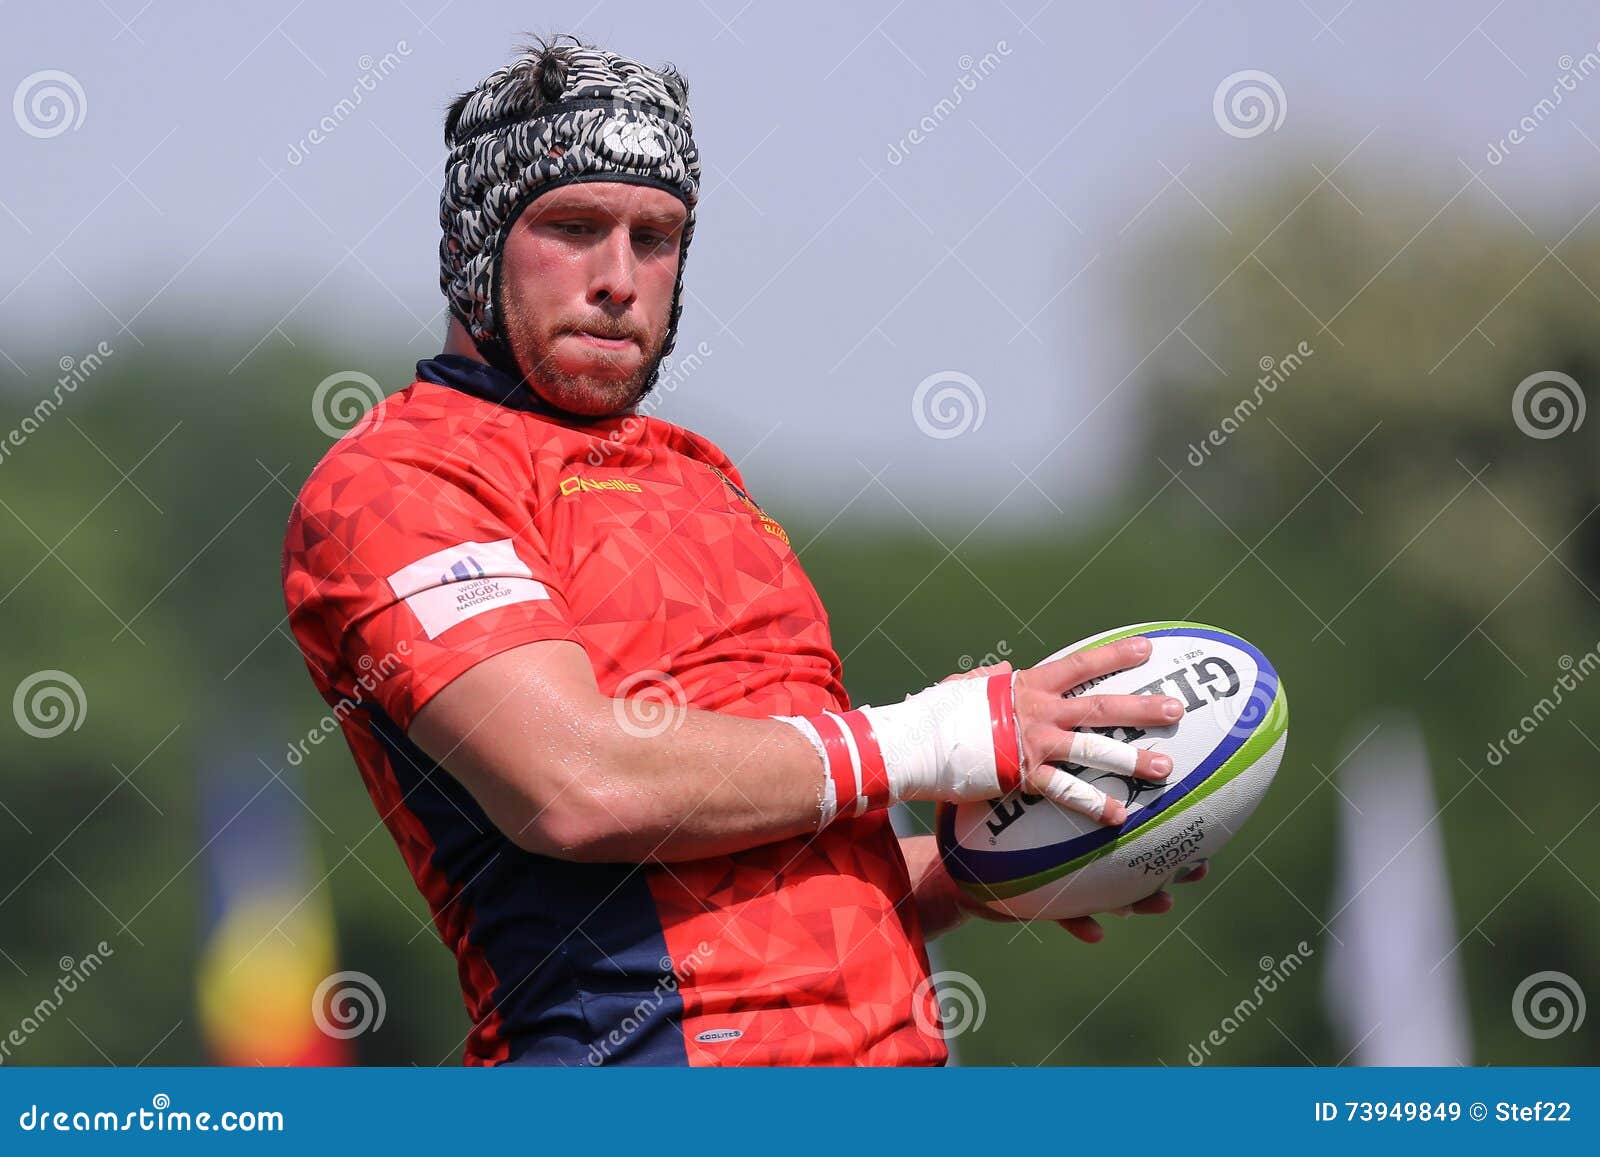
xmin=283 ymin=38 xmax=1205 ymax=1066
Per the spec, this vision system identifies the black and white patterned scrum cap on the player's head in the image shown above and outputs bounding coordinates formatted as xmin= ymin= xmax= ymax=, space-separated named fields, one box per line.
xmin=438 ymin=45 xmax=701 ymax=376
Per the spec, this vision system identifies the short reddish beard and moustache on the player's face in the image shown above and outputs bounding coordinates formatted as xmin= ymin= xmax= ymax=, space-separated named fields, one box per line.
xmin=506 ymin=302 xmax=667 ymax=418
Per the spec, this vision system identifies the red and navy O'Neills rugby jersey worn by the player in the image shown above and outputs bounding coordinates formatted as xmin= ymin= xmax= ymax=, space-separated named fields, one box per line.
xmin=283 ymin=355 xmax=946 ymax=1066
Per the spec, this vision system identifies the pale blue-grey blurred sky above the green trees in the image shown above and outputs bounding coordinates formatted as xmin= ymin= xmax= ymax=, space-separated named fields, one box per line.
xmin=0 ymin=0 xmax=1600 ymax=523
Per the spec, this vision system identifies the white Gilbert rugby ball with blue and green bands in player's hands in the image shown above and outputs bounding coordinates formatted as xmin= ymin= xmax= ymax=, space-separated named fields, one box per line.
xmin=938 ymin=623 xmax=1290 ymax=920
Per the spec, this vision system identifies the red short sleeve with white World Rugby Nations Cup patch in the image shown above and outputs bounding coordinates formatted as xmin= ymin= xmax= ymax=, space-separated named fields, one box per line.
xmin=283 ymin=448 xmax=576 ymax=728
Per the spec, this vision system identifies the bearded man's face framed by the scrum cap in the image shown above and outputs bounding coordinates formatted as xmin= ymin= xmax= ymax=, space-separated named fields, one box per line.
xmin=501 ymin=181 xmax=688 ymax=418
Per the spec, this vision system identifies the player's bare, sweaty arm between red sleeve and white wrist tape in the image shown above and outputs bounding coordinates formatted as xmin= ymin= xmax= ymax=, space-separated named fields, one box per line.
xmin=408 ymin=642 xmax=822 ymax=864
